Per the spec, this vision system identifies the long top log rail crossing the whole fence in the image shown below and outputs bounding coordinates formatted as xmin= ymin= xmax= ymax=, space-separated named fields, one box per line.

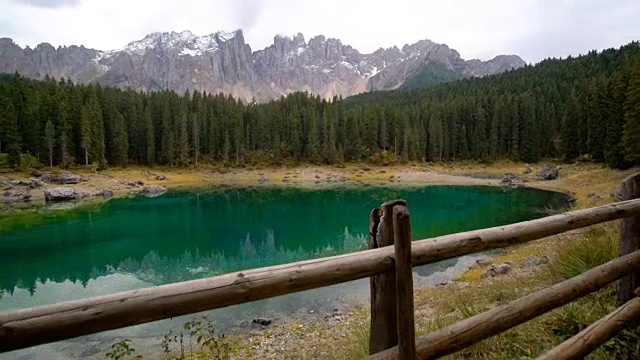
xmin=0 ymin=199 xmax=640 ymax=352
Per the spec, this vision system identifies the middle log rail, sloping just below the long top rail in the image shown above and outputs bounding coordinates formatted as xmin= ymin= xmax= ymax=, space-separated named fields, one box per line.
xmin=367 ymin=251 xmax=640 ymax=360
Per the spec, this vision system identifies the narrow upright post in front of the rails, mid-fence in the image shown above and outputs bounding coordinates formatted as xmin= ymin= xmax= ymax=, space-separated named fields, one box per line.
xmin=393 ymin=205 xmax=416 ymax=360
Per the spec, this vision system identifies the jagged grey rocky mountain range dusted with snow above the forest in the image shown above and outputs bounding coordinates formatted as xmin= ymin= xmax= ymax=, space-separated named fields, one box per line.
xmin=0 ymin=30 xmax=525 ymax=102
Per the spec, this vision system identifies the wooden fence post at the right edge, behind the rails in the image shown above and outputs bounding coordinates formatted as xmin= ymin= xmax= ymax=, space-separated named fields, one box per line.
xmin=616 ymin=174 xmax=640 ymax=306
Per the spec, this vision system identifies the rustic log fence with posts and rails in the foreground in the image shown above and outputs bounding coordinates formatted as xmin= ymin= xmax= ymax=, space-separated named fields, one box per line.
xmin=0 ymin=174 xmax=640 ymax=359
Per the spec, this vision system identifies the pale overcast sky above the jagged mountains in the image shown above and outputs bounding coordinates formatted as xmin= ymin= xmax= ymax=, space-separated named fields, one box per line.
xmin=0 ymin=0 xmax=640 ymax=63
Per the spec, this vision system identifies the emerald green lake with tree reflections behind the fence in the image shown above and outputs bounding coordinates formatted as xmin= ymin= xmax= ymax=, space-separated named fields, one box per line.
xmin=0 ymin=186 xmax=567 ymax=359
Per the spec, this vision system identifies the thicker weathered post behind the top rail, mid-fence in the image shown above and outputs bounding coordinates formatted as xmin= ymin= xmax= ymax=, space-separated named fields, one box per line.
xmin=369 ymin=200 xmax=407 ymax=354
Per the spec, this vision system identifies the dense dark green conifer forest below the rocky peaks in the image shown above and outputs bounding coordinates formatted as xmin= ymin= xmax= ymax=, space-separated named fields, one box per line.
xmin=0 ymin=42 xmax=640 ymax=168
